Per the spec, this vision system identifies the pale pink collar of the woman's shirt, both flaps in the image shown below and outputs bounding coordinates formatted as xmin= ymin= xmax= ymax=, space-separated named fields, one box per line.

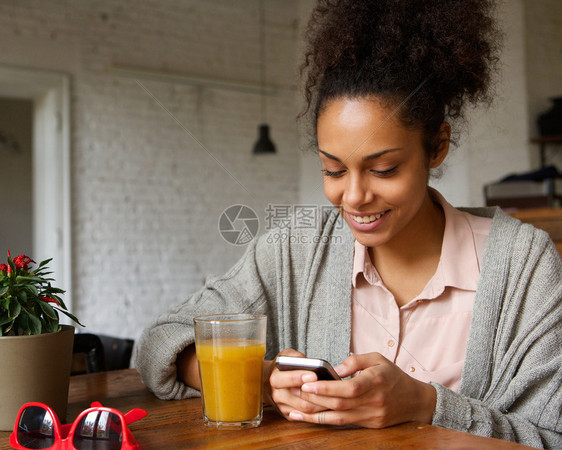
xmin=352 ymin=188 xmax=480 ymax=298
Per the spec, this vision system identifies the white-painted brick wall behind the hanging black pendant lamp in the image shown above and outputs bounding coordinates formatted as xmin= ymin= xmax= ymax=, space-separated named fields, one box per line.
xmin=0 ymin=0 xmax=299 ymax=338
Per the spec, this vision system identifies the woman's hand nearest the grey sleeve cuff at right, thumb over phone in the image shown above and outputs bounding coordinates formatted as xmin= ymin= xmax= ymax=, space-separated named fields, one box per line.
xmin=283 ymin=353 xmax=437 ymax=428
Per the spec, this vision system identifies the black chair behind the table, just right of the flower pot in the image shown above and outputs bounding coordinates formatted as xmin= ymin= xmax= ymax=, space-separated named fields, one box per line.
xmin=71 ymin=333 xmax=135 ymax=375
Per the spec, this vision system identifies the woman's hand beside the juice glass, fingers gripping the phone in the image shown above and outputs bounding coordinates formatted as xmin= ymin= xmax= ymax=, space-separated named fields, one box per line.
xmin=264 ymin=349 xmax=326 ymax=420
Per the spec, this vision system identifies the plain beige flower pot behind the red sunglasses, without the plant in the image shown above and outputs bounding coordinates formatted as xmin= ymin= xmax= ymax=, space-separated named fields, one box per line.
xmin=0 ymin=325 xmax=74 ymax=431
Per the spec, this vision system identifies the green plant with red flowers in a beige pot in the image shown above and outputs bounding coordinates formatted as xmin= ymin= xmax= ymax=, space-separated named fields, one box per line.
xmin=0 ymin=251 xmax=81 ymax=431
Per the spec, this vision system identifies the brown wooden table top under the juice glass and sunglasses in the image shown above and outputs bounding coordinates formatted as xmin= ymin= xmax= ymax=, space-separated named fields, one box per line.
xmin=0 ymin=369 xmax=526 ymax=449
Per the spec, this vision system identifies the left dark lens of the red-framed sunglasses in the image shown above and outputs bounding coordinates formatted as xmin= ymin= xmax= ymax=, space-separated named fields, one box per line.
xmin=18 ymin=406 xmax=55 ymax=449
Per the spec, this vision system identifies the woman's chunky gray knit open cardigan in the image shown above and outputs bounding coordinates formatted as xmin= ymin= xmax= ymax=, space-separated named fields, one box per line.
xmin=135 ymin=209 xmax=562 ymax=448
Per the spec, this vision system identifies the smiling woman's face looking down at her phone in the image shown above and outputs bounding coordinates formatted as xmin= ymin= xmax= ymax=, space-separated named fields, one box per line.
xmin=317 ymin=98 xmax=448 ymax=247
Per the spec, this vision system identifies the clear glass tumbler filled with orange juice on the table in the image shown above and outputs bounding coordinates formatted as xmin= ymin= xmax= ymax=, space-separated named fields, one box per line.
xmin=193 ymin=314 xmax=267 ymax=430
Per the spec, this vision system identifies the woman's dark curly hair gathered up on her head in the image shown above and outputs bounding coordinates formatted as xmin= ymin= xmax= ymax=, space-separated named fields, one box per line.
xmin=300 ymin=0 xmax=501 ymax=154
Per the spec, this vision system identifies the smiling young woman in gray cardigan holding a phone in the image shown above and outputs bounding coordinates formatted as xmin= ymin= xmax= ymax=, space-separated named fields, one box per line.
xmin=137 ymin=0 xmax=562 ymax=447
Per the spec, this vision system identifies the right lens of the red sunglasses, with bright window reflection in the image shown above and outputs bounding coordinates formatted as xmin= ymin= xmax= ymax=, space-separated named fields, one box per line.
xmin=72 ymin=411 xmax=123 ymax=450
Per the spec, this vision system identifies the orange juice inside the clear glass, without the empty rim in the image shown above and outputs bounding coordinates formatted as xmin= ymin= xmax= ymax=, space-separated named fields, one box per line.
xmin=196 ymin=339 xmax=265 ymax=422
